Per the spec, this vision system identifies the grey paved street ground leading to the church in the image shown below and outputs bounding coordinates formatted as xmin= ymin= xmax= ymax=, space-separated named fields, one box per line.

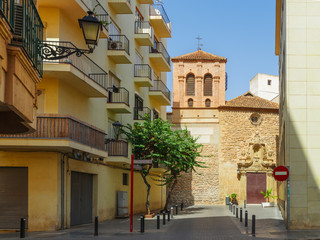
xmin=0 ymin=205 xmax=320 ymax=240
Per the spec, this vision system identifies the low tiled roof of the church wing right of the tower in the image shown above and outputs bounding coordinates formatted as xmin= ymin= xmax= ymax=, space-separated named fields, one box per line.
xmin=221 ymin=91 xmax=279 ymax=109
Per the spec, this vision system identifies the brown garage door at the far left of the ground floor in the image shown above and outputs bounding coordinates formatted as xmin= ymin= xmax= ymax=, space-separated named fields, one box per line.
xmin=0 ymin=167 xmax=28 ymax=229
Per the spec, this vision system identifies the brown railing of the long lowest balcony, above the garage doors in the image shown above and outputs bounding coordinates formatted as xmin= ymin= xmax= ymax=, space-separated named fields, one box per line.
xmin=0 ymin=114 xmax=105 ymax=150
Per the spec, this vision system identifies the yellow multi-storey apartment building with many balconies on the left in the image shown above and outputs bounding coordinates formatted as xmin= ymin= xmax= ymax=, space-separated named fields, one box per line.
xmin=0 ymin=0 xmax=171 ymax=231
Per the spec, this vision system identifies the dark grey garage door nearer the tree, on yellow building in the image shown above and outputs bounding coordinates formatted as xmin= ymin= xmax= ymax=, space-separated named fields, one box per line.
xmin=70 ymin=172 xmax=93 ymax=226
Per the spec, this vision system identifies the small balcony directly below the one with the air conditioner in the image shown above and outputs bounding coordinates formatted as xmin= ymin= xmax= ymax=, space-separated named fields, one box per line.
xmin=107 ymin=87 xmax=131 ymax=113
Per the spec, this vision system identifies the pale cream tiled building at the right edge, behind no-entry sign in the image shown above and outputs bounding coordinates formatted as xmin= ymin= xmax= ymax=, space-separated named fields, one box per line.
xmin=276 ymin=0 xmax=320 ymax=229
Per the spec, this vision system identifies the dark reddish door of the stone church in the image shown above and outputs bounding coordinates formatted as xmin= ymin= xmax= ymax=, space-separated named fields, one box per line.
xmin=247 ymin=173 xmax=266 ymax=204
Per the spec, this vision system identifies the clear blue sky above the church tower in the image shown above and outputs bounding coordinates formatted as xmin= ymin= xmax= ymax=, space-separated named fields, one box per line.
xmin=162 ymin=0 xmax=278 ymax=110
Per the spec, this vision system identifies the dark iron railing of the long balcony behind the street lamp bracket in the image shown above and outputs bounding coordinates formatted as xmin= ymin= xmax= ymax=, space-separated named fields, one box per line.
xmin=42 ymin=41 xmax=108 ymax=89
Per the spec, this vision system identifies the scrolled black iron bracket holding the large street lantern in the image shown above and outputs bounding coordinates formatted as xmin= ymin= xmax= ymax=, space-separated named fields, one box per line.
xmin=40 ymin=43 xmax=94 ymax=60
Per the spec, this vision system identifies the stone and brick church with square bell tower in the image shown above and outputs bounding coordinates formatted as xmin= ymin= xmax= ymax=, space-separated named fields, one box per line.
xmin=168 ymin=50 xmax=279 ymax=205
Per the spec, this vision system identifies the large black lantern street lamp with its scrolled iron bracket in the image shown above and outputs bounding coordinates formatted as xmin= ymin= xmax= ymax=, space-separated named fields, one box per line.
xmin=40 ymin=11 xmax=102 ymax=60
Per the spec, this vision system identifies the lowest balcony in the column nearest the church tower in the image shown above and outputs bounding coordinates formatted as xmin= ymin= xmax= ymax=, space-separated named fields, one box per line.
xmin=149 ymin=80 xmax=171 ymax=106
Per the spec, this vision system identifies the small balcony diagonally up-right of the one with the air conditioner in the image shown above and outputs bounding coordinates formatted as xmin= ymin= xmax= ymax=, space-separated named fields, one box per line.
xmin=134 ymin=21 xmax=154 ymax=46
